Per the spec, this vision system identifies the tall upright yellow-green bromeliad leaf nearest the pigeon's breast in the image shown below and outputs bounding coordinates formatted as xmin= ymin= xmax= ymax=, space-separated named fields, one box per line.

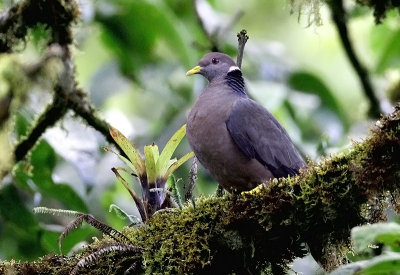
xmin=156 ymin=124 xmax=186 ymax=178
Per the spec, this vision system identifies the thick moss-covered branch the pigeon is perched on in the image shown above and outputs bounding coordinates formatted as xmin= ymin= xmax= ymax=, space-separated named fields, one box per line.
xmin=0 ymin=105 xmax=400 ymax=274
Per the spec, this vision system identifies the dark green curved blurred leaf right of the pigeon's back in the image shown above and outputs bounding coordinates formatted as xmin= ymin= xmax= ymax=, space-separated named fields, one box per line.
xmin=287 ymin=71 xmax=349 ymax=129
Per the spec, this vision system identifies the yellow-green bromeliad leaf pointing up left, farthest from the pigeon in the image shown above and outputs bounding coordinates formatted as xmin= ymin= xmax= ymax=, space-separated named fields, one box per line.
xmin=110 ymin=127 xmax=146 ymax=177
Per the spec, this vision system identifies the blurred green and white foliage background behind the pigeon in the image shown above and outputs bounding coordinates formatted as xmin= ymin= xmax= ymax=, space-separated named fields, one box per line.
xmin=0 ymin=0 xmax=400 ymax=272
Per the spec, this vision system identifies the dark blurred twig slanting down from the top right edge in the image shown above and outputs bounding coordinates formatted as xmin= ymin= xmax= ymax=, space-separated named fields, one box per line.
xmin=328 ymin=0 xmax=380 ymax=117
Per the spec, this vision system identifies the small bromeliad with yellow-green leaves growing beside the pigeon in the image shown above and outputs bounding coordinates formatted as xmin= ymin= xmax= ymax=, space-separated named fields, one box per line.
xmin=105 ymin=124 xmax=194 ymax=222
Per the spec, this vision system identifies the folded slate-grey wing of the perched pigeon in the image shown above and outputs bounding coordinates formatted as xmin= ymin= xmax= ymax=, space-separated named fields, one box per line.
xmin=226 ymin=98 xmax=304 ymax=177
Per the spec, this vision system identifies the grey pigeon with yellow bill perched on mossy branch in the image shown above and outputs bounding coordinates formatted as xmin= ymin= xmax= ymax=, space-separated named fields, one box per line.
xmin=186 ymin=52 xmax=305 ymax=193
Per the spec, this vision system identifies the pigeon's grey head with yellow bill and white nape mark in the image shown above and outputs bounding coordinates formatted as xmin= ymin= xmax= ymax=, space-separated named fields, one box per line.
xmin=186 ymin=52 xmax=239 ymax=82
